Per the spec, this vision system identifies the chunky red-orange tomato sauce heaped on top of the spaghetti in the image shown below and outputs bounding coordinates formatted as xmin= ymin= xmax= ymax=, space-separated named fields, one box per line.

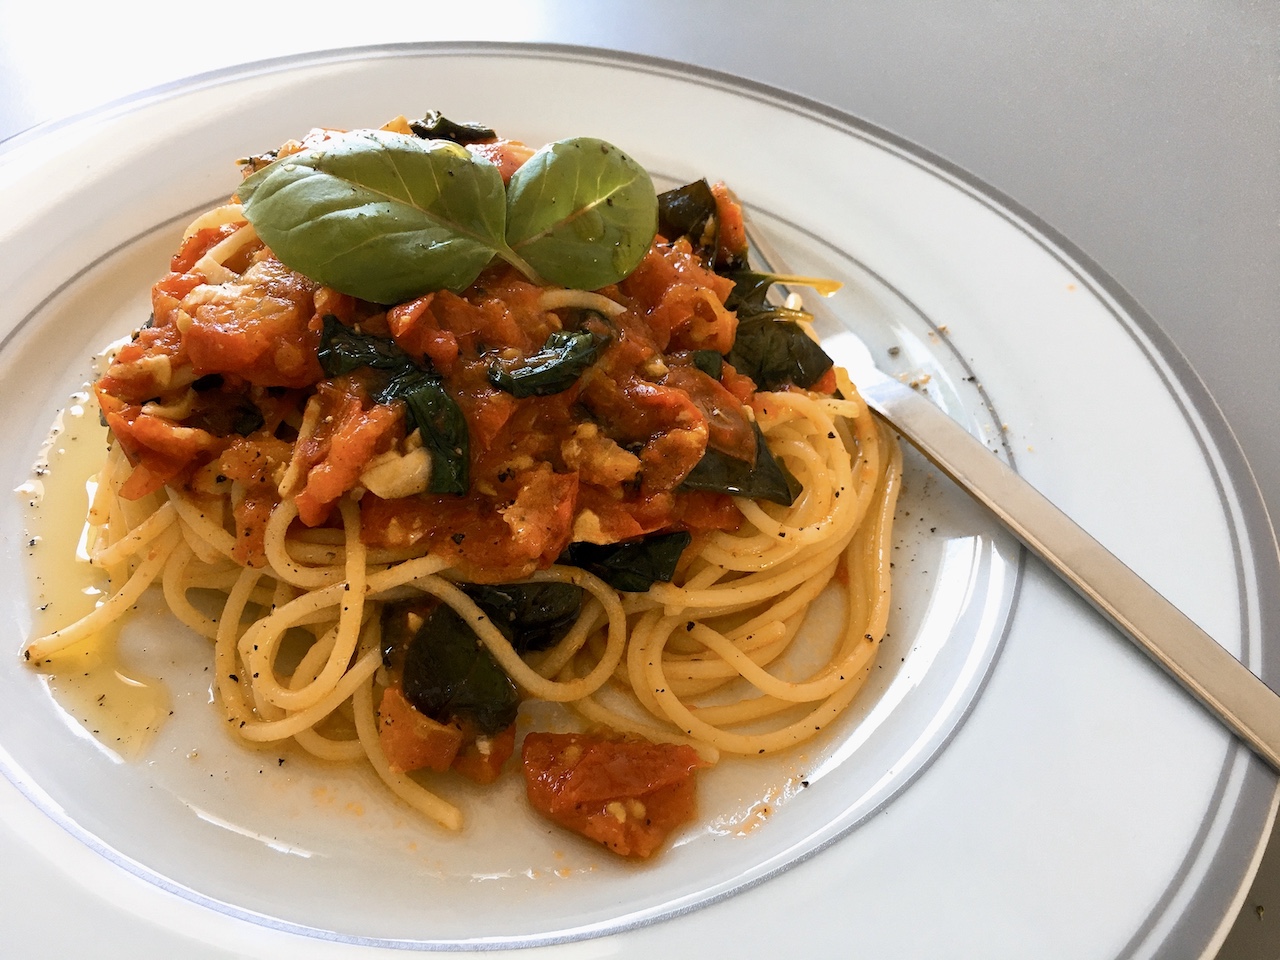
xmin=96 ymin=180 xmax=755 ymax=581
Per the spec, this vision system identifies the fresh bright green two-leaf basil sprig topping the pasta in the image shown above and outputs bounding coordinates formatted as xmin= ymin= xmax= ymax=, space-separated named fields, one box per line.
xmin=238 ymin=124 xmax=658 ymax=303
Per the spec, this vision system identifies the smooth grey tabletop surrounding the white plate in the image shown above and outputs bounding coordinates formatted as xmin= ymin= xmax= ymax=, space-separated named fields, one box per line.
xmin=0 ymin=0 xmax=1280 ymax=960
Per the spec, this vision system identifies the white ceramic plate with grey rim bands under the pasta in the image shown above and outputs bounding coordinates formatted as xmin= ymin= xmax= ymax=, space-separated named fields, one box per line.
xmin=0 ymin=46 xmax=1280 ymax=956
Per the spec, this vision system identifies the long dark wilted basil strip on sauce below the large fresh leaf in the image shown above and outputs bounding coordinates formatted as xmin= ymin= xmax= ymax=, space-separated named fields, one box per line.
xmin=317 ymin=314 xmax=471 ymax=494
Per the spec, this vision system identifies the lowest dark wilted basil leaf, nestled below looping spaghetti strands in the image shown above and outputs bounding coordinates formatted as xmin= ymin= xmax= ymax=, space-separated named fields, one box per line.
xmin=403 ymin=603 xmax=520 ymax=736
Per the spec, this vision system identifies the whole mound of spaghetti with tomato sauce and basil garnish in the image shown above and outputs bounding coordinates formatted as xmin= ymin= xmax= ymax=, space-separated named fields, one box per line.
xmin=26 ymin=114 xmax=900 ymax=856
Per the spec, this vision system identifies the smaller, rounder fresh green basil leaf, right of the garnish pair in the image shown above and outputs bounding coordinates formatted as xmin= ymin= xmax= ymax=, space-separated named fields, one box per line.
xmin=507 ymin=137 xmax=658 ymax=291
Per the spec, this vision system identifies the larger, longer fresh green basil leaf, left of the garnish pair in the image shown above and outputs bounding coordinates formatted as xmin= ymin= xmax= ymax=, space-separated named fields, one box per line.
xmin=238 ymin=131 xmax=506 ymax=303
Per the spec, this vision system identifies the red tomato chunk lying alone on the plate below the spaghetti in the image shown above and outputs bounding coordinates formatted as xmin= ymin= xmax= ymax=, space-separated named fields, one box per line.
xmin=521 ymin=732 xmax=705 ymax=859
